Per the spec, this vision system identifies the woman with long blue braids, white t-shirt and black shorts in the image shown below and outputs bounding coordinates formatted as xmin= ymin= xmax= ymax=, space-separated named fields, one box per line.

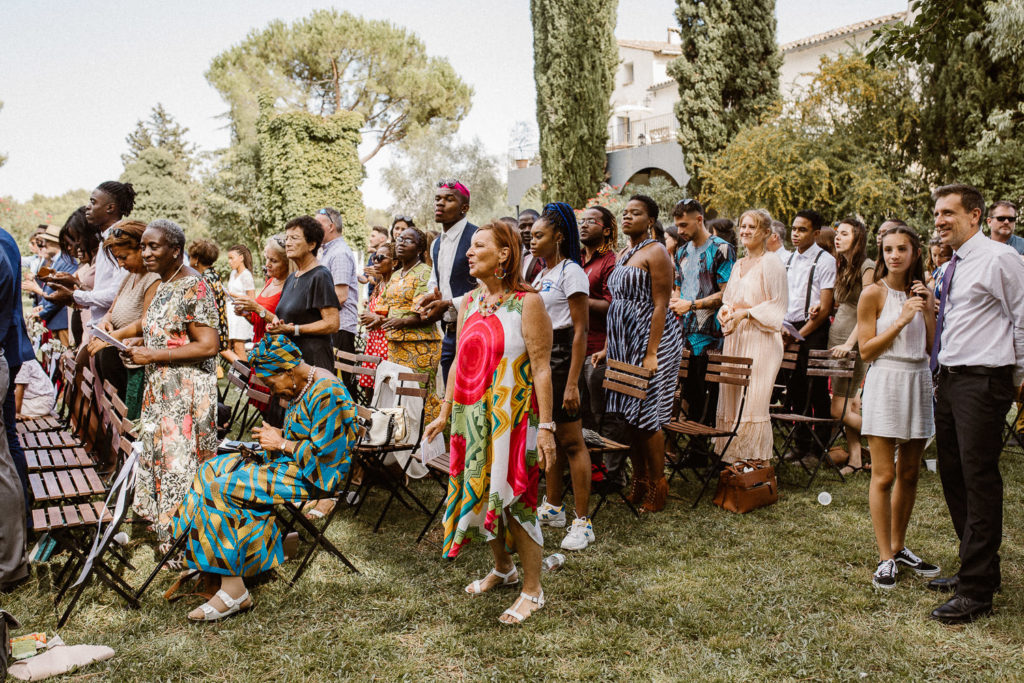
xmin=529 ymin=202 xmax=594 ymax=550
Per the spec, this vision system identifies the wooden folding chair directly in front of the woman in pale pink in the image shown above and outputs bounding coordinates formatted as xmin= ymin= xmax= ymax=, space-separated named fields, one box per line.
xmin=665 ymin=350 xmax=754 ymax=508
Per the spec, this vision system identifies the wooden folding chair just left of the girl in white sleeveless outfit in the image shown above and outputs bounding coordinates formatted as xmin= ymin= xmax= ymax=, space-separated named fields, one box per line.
xmin=770 ymin=349 xmax=857 ymax=488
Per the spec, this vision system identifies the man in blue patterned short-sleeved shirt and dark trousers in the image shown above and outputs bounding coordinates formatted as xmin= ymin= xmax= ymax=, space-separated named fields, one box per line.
xmin=669 ymin=200 xmax=736 ymax=425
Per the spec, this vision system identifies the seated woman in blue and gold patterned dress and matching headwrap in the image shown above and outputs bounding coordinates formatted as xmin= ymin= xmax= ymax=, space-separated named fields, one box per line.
xmin=172 ymin=334 xmax=356 ymax=622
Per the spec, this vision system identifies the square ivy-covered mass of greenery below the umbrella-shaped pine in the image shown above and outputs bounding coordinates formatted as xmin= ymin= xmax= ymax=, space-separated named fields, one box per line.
xmin=256 ymin=94 xmax=367 ymax=247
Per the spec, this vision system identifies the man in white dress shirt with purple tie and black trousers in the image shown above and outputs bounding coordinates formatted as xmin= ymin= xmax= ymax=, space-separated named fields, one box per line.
xmin=929 ymin=184 xmax=1024 ymax=624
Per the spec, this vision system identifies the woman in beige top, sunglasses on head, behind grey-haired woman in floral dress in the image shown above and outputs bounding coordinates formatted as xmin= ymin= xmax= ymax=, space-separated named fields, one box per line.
xmin=88 ymin=220 xmax=160 ymax=420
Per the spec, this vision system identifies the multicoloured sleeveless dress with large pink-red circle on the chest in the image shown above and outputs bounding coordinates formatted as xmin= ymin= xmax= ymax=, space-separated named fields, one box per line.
xmin=441 ymin=290 xmax=544 ymax=559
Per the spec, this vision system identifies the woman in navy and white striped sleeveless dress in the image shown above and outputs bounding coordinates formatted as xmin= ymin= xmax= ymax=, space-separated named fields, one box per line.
xmin=593 ymin=195 xmax=683 ymax=512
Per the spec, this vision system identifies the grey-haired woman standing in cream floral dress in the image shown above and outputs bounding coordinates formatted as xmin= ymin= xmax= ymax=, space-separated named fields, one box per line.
xmin=125 ymin=218 xmax=219 ymax=544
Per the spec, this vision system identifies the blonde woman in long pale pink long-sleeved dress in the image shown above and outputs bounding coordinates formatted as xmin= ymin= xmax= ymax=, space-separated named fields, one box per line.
xmin=715 ymin=209 xmax=790 ymax=462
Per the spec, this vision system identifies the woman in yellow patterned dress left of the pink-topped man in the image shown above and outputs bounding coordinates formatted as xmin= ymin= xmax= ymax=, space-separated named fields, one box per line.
xmin=381 ymin=227 xmax=441 ymax=423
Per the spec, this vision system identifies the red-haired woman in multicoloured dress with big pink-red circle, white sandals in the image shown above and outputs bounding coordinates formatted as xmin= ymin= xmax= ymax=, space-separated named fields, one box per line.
xmin=424 ymin=221 xmax=555 ymax=624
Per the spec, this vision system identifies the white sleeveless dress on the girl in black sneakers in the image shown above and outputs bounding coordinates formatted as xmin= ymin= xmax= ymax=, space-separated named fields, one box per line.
xmin=861 ymin=281 xmax=935 ymax=442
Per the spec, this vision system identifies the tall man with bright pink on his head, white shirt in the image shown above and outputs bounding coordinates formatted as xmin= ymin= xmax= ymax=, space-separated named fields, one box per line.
xmin=421 ymin=179 xmax=476 ymax=383
